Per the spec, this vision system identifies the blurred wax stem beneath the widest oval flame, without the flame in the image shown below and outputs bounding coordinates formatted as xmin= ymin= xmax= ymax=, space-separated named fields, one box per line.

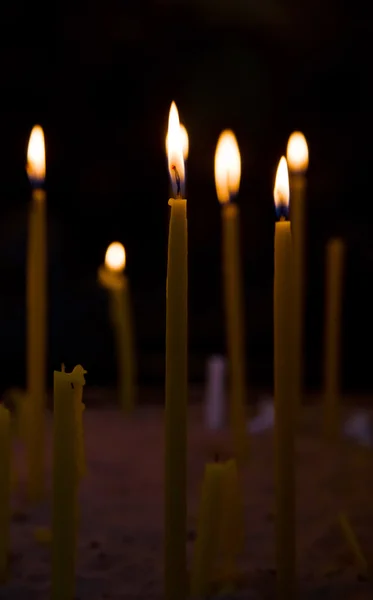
xmin=222 ymin=203 xmax=249 ymax=463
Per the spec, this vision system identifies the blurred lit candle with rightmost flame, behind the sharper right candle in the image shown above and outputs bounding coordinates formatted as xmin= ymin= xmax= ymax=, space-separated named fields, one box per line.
xmin=286 ymin=131 xmax=308 ymax=418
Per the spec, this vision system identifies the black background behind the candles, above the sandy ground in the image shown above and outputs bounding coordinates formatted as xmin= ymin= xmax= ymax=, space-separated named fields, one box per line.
xmin=0 ymin=0 xmax=373 ymax=390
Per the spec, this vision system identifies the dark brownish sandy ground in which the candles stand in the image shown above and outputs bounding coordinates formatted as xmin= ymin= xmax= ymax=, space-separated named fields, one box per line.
xmin=0 ymin=407 xmax=373 ymax=600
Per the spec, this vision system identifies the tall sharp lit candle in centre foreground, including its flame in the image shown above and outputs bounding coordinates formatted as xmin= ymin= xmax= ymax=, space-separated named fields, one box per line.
xmin=164 ymin=102 xmax=188 ymax=600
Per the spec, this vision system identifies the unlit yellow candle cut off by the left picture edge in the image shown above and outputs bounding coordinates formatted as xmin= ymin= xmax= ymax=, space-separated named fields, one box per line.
xmin=0 ymin=404 xmax=11 ymax=583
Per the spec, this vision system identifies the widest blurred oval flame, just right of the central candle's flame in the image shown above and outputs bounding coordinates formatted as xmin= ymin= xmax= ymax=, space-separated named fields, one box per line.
xmin=215 ymin=129 xmax=241 ymax=204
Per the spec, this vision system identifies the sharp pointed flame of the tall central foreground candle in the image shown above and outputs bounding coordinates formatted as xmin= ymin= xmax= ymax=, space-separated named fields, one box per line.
xmin=167 ymin=102 xmax=185 ymax=197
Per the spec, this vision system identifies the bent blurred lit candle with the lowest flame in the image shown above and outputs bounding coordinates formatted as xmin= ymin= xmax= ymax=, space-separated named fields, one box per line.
xmin=98 ymin=242 xmax=136 ymax=413
